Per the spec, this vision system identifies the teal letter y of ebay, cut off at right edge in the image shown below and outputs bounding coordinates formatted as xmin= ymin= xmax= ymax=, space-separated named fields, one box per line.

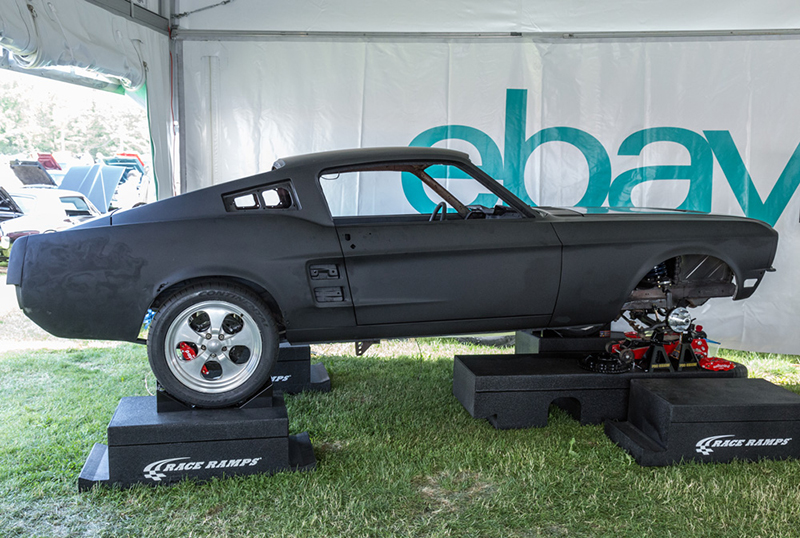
xmin=703 ymin=131 xmax=800 ymax=226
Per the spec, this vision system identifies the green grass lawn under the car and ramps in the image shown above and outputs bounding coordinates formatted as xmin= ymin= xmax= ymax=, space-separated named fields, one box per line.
xmin=0 ymin=340 xmax=800 ymax=537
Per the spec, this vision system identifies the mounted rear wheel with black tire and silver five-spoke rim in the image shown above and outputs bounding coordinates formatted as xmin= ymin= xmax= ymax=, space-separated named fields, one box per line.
xmin=147 ymin=283 xmax=278 ymax=407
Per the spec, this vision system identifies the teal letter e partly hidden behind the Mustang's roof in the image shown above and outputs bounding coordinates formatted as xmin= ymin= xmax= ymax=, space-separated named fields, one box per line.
xmin=402 ymin=125 xmax=503 ymax=213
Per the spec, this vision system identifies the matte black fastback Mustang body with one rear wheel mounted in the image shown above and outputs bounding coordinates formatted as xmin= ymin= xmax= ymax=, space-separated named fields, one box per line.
xmin=7 ymin=148 xmax=778 ymax=407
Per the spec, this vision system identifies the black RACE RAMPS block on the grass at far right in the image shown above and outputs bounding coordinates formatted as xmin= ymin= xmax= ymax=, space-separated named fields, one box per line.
xmin=605 ymin=379 xmax=800 ymax=466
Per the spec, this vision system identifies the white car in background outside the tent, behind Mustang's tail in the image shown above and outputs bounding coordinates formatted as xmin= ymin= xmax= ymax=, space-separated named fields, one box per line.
xmin=0 ymin=186 xmax=102 ymax=260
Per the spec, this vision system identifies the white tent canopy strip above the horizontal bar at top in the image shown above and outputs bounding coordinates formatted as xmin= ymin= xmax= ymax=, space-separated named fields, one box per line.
xmin=170 ymin=0 xmax=800 ymax=34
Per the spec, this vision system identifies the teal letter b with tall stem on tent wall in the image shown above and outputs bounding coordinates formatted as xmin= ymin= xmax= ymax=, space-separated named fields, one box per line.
xmin=503 ymin=90 xmax=611 ymax=206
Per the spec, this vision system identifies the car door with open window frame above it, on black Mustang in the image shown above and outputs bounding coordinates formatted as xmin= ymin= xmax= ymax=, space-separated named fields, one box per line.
xmin=320 ymin=160 xmax=561 ymax=326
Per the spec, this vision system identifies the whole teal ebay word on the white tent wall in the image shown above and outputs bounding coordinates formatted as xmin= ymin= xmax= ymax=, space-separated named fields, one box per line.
xmin=402 ymin=89 xmax=800 ymax=226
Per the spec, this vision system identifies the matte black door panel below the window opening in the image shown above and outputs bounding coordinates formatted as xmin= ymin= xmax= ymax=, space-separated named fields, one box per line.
xmin=336 ymin=215 xmax=561 ymax=325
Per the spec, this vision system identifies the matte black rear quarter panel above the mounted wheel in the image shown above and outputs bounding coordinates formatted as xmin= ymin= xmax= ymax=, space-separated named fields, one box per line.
xmin=15 ymin=213 xmax=346 ymax=341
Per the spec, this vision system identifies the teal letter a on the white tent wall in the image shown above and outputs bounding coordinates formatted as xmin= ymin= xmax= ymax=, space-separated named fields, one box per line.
xmin=608 ymin=127 xmax=714 ymax=213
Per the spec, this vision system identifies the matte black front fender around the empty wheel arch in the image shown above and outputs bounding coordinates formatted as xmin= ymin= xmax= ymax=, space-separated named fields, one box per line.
xmin=551 ymin=214 xmax=777 ymax=326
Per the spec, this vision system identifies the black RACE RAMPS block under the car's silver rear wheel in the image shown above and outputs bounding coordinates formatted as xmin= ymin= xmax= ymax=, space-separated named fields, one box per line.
xmin=78 ymin=392 xmax=316 ymax=491
